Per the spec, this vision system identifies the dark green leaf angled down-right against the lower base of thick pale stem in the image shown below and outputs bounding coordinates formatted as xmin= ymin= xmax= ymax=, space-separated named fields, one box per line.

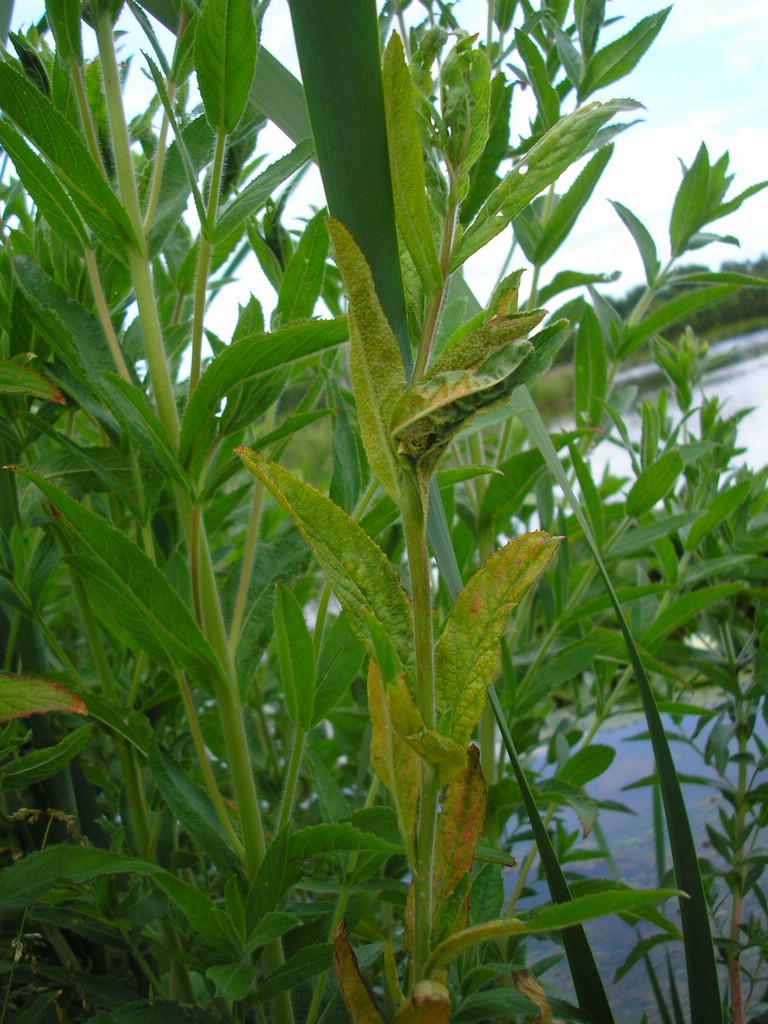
xmin=148 ymin=739 xmax=240 ymax=873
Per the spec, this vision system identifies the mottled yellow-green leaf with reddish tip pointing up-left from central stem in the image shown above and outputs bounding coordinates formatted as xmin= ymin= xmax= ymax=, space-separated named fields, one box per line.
xmin=237 ymin=450 xmax=413 ymax=666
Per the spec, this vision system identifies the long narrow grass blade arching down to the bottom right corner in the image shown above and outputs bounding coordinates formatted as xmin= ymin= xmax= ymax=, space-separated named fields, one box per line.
xmin=514 ymin=388 xmax=723 ymax=1024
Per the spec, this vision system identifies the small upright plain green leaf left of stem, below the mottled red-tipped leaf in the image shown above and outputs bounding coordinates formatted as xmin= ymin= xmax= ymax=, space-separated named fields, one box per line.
xmin=274 ymin=583 xmax=314 ymax=731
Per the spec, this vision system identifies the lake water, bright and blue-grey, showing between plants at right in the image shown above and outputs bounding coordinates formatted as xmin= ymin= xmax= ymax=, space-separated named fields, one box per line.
xmin=508 ymin=330 xmax=768 ymax=1024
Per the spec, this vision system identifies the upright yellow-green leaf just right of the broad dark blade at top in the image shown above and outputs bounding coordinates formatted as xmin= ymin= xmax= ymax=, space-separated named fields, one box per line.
xmin=383 ymin=32 xmax=442 ymax=296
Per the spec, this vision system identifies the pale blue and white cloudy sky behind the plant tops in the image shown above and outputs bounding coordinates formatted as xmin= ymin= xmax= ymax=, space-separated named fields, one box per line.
xmin=7 ymin=0 xmax=768 ymax=323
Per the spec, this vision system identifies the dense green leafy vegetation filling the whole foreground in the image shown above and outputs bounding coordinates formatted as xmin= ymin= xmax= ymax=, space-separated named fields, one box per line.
xmin=0 ymin=0 xmax=768 ymax=1024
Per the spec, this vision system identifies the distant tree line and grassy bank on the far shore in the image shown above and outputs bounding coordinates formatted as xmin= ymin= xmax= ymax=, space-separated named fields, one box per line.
xmin=609 ymin=254 xmax=768 ymax=341
